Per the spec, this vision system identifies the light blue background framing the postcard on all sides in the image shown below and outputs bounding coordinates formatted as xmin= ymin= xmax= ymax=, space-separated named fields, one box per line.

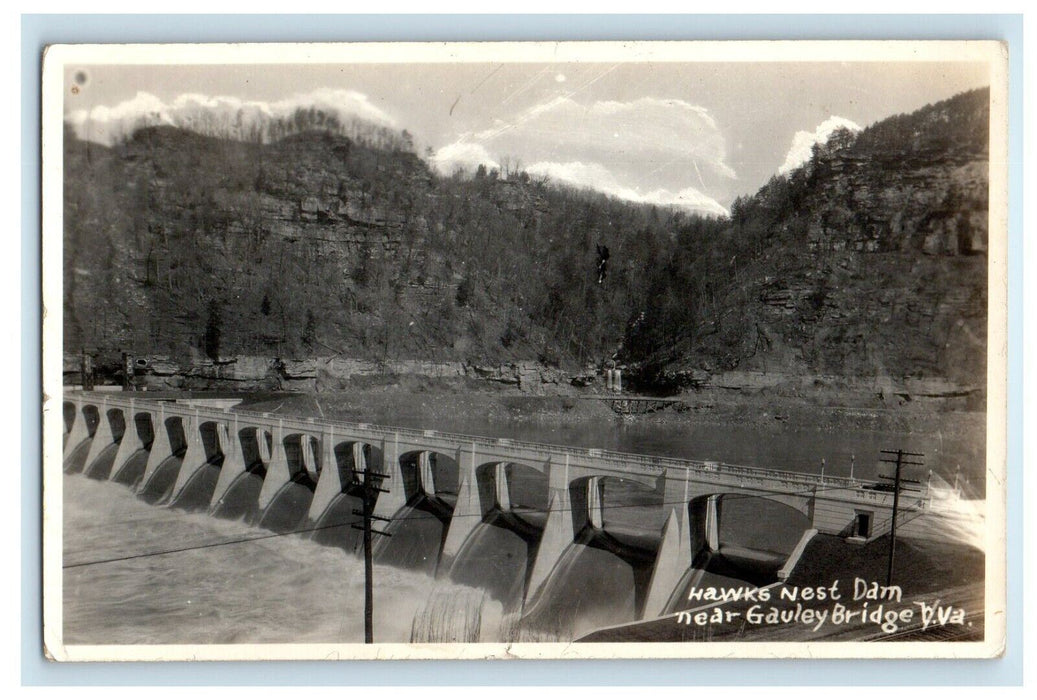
xmin=21 ymin=15 xmax=1022 ymax=685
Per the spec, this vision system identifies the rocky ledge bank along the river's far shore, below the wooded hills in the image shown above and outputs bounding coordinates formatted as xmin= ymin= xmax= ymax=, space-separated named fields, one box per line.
xmin=71 ymin=355 xmax=985 ymax=420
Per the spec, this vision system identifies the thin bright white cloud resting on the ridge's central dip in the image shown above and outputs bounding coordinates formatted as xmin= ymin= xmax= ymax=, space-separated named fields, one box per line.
xmin=526 ymin=161 xmax=728 ymax=216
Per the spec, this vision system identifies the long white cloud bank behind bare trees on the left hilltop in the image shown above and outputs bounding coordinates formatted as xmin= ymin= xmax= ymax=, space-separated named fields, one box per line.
xmin=67 ymin=88 xmax=397 ymax=145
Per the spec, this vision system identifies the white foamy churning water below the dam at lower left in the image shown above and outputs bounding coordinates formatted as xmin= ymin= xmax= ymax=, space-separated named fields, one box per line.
xmin=63 ymin=475 xmax=501 ymax=644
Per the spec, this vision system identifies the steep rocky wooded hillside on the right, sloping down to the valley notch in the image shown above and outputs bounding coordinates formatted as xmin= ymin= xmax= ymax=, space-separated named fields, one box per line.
xmin=636 ymin=90 xmax=989 ymax=386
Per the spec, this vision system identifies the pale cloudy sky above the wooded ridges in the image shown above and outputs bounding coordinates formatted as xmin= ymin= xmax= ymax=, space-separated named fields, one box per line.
xmin=64 ymin=61 xmax=989 ymax=215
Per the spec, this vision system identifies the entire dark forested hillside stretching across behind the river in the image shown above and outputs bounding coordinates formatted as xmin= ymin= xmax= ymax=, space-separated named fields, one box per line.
xmin=64 ymin=90 xmax=988 ymax=386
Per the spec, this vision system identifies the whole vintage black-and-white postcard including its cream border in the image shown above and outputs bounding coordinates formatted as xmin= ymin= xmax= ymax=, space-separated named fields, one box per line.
xmin=43 ymin=41 xmax=1008 ymax=661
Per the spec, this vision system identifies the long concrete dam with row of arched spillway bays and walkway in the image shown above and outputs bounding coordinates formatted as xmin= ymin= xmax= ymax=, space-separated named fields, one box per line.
xmin=62 ymin=392 xmax=974 ymax=639
